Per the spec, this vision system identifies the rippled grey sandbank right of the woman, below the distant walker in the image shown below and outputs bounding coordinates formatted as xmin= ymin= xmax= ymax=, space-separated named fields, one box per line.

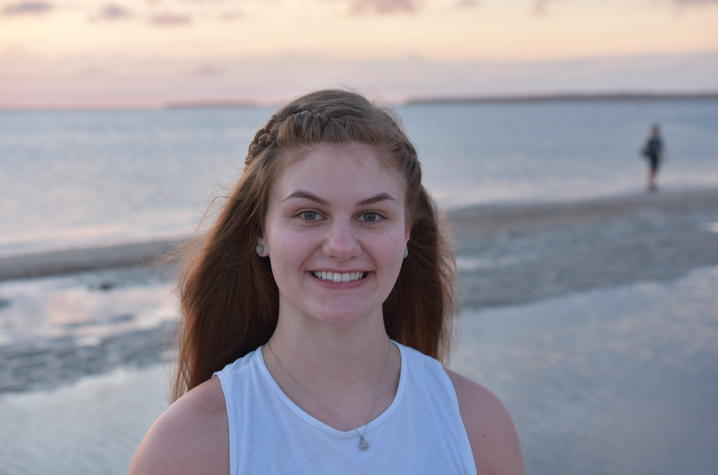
xmin=451 ymin=189 xmax=718 ymax=308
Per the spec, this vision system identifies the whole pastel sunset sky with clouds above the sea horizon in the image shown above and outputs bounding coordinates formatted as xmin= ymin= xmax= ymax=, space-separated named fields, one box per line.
xmin=0 ymin=0 xmax=718 ymax=108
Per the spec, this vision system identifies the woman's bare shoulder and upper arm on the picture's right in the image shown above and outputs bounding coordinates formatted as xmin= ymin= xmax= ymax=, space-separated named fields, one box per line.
xmin=446 ymin=369 xmax=524 ymax=475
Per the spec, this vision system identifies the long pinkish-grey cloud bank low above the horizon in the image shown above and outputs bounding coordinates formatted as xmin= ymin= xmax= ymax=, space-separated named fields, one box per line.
xmin=0 ymin=51 xmax=718 ymax=108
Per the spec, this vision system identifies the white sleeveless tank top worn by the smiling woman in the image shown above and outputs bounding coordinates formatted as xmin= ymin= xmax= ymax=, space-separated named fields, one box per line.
xmin=215 ymin=342 xmax=477 ymax=475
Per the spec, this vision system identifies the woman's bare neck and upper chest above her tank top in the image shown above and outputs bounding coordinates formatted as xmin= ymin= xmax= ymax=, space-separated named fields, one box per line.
xmin=263 ymin=306 xmax=401 ymax=430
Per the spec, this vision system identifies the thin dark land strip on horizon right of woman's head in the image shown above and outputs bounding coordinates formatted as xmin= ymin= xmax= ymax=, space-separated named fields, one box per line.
xmin=405 ymin=91 xmax=718 ymax=106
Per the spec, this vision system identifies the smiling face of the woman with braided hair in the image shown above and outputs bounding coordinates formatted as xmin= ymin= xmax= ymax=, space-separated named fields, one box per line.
xmin=259 ymin=143 xmax=410 ymax=327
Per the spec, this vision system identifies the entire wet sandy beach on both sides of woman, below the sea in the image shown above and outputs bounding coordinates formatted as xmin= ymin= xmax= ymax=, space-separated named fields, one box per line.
xmin=0 ymin=187 xmax=718 ymax=475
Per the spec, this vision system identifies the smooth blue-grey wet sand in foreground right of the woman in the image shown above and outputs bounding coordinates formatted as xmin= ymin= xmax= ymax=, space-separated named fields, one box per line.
xmin=452 ymin=267 xmax=718 ymax=475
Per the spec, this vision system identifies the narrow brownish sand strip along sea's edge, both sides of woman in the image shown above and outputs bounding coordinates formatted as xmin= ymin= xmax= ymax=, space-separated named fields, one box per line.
xmin=0 ymin=187 xmax=718 ymax=282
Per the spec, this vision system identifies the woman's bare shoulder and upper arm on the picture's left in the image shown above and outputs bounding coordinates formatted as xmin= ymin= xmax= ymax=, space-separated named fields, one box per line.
xmin=129 ymin=378 xmax=229 ymax=475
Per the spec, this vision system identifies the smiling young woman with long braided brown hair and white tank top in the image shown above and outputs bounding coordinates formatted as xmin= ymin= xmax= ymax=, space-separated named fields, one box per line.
xmin=130 ymin=90 xmax=523 ymax=475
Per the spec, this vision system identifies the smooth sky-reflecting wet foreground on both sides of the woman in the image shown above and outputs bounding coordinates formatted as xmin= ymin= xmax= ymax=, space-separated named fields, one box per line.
xmin=0 ymin=267 xmax=718 ymax=475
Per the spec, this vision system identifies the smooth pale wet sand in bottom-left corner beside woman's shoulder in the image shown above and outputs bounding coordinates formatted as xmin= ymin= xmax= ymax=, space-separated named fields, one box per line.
xmin=0 ymin=364 xmax=170 ymax=475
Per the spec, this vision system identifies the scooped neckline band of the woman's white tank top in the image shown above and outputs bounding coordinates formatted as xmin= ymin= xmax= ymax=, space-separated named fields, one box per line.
xmin=256 ymin=340 xmax=407 ymax=439
